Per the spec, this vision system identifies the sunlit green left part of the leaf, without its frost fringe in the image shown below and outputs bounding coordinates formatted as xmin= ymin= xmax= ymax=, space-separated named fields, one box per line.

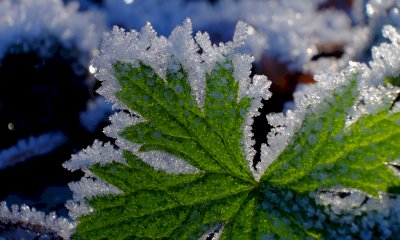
xmin=74 ymin=63 xmax=256 ymax=239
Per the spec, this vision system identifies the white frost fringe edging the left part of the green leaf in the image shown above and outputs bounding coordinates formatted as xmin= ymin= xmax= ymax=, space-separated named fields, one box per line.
xmin=64 ymin=20 xmax=269 ymax=238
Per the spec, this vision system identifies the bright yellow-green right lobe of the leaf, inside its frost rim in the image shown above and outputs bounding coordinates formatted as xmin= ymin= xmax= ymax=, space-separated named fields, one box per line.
xmin=262 ymin=80 xmax=400 ymax=197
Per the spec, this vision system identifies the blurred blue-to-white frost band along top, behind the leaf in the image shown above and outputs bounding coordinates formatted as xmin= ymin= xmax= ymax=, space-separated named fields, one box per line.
xmin=105 ymin=0 xmax=369 ymax=72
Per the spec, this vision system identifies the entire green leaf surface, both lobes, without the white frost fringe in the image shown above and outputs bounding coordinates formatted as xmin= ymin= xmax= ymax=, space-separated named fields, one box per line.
xmin=73 ymin=63 xmax=400 ymax=239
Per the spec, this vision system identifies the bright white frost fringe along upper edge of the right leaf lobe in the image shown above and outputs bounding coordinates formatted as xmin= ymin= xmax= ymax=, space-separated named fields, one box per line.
xmin=261 ymin=26 xmax=400 ymax=175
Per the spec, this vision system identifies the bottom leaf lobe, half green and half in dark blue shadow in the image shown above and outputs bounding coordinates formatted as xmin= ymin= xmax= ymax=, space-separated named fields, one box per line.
xmin=221 ymin=185 xmax=330 ymax=239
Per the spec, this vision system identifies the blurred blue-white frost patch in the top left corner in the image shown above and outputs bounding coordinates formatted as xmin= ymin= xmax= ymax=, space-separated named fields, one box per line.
xmin=0 ymin=0 xmax=105 ymax=65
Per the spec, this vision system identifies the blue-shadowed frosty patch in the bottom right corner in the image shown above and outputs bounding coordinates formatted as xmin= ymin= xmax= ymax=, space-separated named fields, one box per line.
xmin=317 ymin=190 xmax=400 ymax=239
